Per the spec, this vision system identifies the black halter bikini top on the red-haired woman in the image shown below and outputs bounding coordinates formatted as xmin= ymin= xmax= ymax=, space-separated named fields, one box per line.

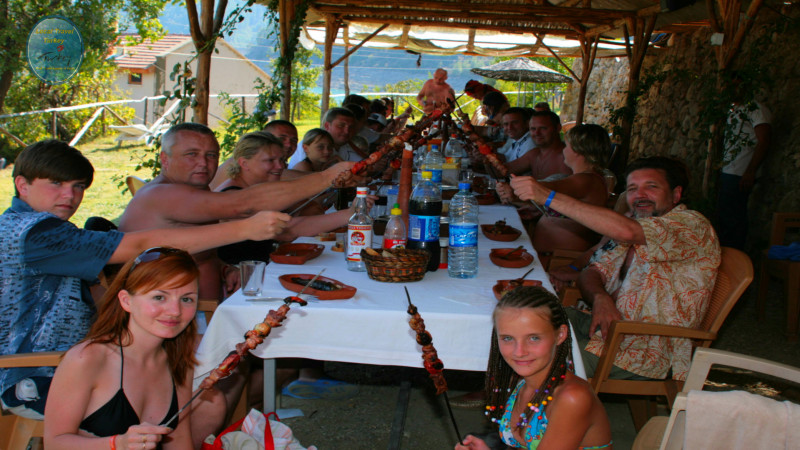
xmin=80 ymin=345 xmax=178 ymax=437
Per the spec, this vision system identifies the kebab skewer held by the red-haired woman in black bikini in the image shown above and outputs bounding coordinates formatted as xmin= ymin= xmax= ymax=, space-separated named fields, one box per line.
xmin=162 ymin=269 xmax=325 ymax=426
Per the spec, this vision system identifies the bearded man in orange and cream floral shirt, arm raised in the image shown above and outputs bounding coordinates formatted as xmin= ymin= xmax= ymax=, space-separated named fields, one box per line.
xmin=511 ymin=157 xmax=720 ymax=380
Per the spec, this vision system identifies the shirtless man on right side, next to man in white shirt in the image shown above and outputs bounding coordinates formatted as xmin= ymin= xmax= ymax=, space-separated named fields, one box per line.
xmin=506 ymin=111 xmax=572 ymax=180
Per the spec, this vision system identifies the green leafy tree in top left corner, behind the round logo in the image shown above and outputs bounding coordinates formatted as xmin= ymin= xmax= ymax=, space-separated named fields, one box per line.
xmin=0 ymin=0 xmax=167 ymax=113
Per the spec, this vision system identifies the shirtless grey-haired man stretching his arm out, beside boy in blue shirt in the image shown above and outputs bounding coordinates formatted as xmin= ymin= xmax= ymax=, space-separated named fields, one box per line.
xmin=119 ymin=123 xmax=353 ymax=300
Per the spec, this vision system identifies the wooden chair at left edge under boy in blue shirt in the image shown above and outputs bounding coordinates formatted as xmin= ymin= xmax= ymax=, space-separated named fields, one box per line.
xmin=0 ymin=352 xmax=64 ymax=450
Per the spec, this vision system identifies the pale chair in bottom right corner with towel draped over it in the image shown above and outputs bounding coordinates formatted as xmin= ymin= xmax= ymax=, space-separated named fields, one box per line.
xmin=633 ymin=348 xmax=800 ymax=450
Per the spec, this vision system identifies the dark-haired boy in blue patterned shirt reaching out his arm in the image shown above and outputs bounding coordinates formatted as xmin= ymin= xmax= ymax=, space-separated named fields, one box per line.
xmin=0 ymin=140 xmax=289 ymax=419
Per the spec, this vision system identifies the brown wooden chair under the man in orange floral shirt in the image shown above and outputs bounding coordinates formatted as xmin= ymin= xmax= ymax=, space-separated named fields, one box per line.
xmin=589 ymin=247 xmax=753 ymax=431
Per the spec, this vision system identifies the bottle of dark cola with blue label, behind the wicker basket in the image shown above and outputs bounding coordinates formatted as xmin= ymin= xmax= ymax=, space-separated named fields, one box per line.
xmin=407 ymin=170 xmax=442 ymax=272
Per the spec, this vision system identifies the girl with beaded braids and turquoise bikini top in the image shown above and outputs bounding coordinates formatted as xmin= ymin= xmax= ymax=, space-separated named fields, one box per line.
xmin=455 ymin=286 xmax=612 ymax=450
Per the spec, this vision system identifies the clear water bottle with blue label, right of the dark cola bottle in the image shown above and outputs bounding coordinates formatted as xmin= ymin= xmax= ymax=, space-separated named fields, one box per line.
xmin=447 ymin=183 xmax=478 ymax=278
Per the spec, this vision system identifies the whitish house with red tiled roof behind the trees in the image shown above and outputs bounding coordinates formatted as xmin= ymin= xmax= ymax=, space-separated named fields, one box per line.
xmin=113 ymin=34 xmax=270 ymax=128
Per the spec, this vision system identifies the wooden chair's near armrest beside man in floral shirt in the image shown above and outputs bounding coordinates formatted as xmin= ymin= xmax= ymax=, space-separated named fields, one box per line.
xmin=591 ymin=320 xmax=717 ymax=392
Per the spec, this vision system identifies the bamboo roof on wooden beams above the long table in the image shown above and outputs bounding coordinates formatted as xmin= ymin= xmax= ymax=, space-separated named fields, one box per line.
xmin=288 ymin=0 xmax=720 ymax=57
